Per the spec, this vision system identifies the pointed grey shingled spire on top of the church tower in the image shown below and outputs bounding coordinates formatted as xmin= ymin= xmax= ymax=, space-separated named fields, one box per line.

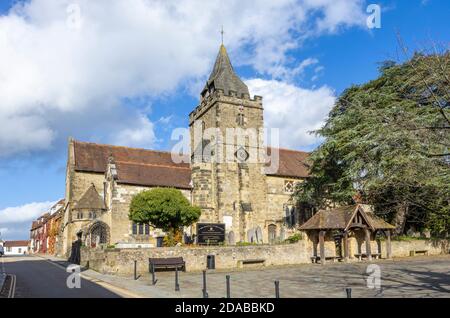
xmin=202 ymin=44 xmax=250 ymax=97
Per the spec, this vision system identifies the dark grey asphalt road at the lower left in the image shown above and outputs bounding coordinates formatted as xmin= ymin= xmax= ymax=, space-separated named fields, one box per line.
xmin=0 ymin=256 xmax=120 ymax=298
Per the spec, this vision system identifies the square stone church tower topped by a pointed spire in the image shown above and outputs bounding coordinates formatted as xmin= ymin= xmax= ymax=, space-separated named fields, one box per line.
xmin=189 ymin=44 xmax=267 ymax=243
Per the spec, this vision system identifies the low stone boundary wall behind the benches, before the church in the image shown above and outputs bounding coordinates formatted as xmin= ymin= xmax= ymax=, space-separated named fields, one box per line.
xmin=81 ymin=240 xmax=450 ymax=275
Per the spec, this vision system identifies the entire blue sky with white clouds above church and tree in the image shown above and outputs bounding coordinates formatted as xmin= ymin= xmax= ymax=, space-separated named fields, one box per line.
xmin=0 ymin=0 xmax=450 ymax=239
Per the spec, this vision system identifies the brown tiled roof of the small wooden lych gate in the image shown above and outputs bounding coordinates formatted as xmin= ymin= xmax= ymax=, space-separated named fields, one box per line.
xmin=300 ymin=204 xmax=395 ymax=230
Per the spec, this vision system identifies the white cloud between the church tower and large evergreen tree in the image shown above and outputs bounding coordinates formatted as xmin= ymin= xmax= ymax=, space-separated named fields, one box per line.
xmin=246 ymin=79 xmax=335 ymax=149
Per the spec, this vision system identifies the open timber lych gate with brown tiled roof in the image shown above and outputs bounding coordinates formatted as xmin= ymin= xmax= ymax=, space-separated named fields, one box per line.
xmin=300 ymin=204 xmax=395 ymax=264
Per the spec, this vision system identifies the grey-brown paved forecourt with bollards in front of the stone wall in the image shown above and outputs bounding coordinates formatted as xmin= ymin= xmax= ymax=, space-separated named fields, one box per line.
xmin=3 ymin=255 xmax=450 ymax=298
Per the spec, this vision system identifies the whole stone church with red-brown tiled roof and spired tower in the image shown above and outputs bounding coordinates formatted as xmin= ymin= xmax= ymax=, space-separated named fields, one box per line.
xmin=60 ymin=45 xmax=311 ymax=254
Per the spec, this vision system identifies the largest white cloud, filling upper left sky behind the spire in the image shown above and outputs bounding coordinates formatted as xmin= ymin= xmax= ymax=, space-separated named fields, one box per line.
xmin=0 ymin=0 xmax=364 ymax=157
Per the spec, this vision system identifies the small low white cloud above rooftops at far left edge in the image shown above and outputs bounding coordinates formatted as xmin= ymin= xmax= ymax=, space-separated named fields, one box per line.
xmin=0 ymin=201 xmax=56 ymax=224
